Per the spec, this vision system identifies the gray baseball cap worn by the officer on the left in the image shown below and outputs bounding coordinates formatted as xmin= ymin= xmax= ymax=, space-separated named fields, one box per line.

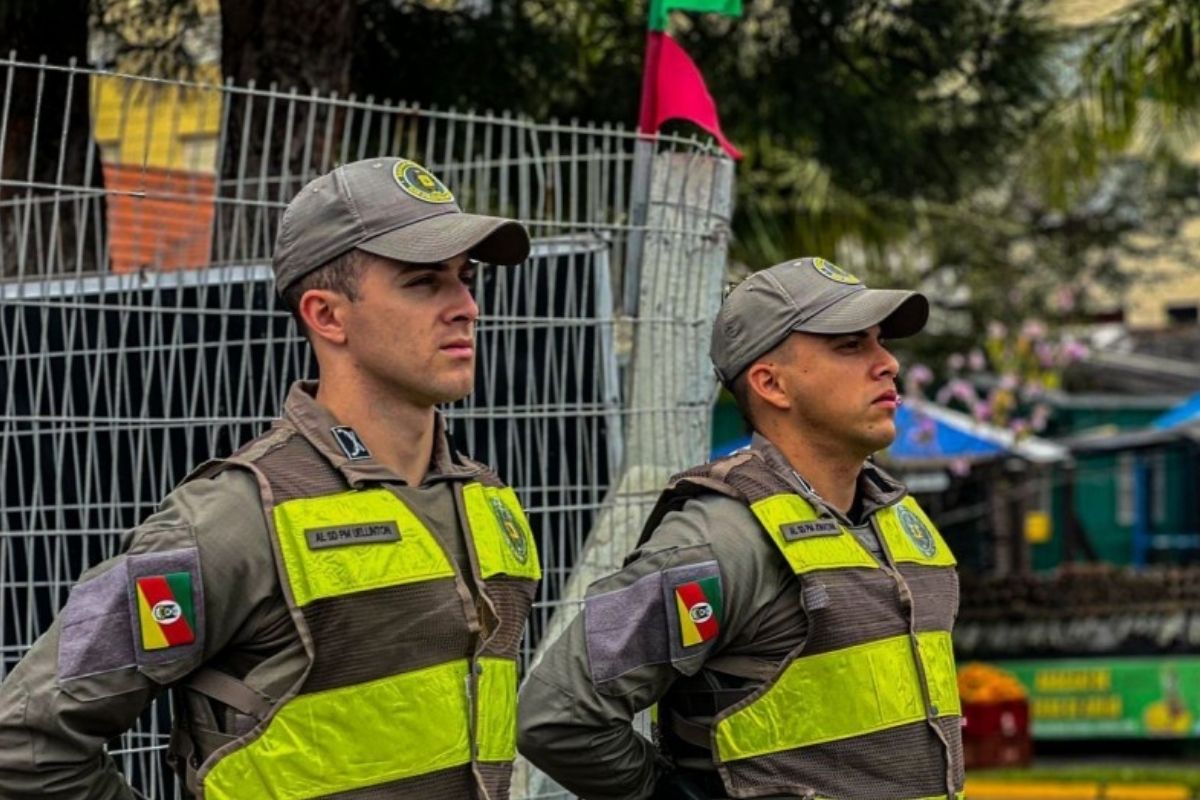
xmin=272 ymin=158 xmax=529 ymax=293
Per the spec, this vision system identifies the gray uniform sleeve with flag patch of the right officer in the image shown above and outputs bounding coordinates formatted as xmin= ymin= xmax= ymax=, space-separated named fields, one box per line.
xmin=518 ymin=497 xmax=768 ymax=800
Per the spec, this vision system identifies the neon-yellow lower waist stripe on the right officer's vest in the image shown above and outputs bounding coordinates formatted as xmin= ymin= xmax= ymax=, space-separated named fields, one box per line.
xmin=715 ymin=631 xmax=960 ymax=762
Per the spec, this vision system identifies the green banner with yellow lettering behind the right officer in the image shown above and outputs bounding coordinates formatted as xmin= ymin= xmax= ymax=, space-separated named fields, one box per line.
xmin=995 ymin=656 xmax=1200 ymax=739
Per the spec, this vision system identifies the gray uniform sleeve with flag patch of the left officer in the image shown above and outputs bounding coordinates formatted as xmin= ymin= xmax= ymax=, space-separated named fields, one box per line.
xmin=0 ymin=470 xmax=275 ymax=800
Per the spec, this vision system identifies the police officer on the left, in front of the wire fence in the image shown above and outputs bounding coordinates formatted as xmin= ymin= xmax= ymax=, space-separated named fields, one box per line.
xmin=0 ymin=158 xmax=540 ymax=800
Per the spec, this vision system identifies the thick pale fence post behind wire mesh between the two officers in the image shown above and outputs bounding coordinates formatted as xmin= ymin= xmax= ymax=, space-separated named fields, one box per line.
xmin=512 ymin=152 xmax=733 ymax=800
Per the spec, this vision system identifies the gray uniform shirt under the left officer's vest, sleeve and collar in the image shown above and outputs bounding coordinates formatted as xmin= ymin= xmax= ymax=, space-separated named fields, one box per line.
xmin=0 ymin=384 xmax=487 ymax=800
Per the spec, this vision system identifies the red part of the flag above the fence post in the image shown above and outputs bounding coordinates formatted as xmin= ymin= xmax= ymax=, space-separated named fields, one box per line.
xmin=637 ymin=30 xmax=742 ymax=158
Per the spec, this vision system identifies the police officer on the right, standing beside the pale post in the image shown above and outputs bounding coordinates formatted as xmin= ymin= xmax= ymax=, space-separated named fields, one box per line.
xmin=518 ymin=258 xmax=962 ymax=800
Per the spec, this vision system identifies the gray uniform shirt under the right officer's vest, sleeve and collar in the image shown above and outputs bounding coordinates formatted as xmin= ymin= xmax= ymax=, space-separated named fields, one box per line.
xmin=517 ymin=437 xmax=905 ymax=800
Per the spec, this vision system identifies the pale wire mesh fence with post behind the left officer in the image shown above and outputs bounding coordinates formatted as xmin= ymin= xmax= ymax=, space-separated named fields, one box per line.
xmin=0 ymin=59 xmax=732 ymax=798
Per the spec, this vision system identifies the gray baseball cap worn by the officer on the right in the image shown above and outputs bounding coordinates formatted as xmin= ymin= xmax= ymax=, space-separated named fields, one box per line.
xmin=709 ymin=258 xmax=929 ymax=384
